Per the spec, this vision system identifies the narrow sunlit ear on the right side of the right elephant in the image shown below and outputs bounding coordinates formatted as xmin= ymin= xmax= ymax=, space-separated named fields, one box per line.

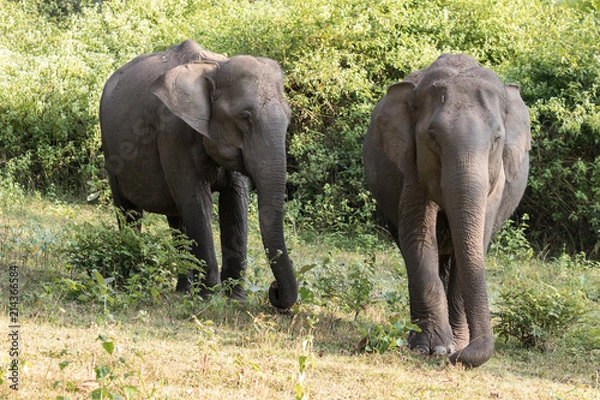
xmin=502 ymin=84 xmax=531 ymax=182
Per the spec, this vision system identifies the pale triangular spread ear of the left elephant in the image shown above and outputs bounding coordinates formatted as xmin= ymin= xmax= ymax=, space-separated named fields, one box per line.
xmin=150 ymin=63 xmax=217 ymax=137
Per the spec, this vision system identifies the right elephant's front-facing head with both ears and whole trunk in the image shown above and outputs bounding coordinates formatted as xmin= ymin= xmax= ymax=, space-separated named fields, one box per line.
xmin=377 ymin=55 xmax=531 ymax=366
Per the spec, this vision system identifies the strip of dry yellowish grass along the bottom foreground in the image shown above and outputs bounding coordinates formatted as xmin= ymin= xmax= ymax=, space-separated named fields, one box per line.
xmin=0 ymin=310 xmax=600 ymax=399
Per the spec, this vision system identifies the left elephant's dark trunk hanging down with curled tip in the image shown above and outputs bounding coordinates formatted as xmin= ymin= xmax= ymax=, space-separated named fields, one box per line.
xmin=246 ymin=104 xmax=298 ymax=309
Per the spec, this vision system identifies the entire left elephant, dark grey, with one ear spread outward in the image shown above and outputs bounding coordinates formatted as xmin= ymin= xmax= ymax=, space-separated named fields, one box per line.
xmin=100 ymin=40 xmax=298 ymax=309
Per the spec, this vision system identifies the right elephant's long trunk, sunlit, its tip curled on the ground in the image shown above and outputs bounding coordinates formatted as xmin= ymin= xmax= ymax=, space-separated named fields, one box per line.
xmin=442 ymin=154 xmax=494 ymax=367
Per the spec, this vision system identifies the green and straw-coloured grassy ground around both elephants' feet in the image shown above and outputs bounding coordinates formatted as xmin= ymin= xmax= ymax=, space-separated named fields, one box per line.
xmin=0 ymin=194 xmax=600 ymax=400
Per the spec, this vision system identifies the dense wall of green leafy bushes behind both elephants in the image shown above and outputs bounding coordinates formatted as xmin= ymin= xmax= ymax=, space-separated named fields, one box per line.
xmin=0 ymin=0 xmax=600 ymax=256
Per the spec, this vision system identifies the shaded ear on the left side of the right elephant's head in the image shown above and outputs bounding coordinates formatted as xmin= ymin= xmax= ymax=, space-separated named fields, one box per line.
xmin=373 ymin=81 xmax=415 ymax=176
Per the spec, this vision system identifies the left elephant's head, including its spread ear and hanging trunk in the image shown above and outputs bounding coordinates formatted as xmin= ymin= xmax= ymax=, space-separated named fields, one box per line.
xmin=153 ymin=56 xmax=298 ymax=309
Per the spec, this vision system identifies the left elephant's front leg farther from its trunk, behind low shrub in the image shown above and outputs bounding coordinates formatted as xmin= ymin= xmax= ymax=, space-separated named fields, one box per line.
xmin=169 ymin=185 xmax=220 ymax=296
